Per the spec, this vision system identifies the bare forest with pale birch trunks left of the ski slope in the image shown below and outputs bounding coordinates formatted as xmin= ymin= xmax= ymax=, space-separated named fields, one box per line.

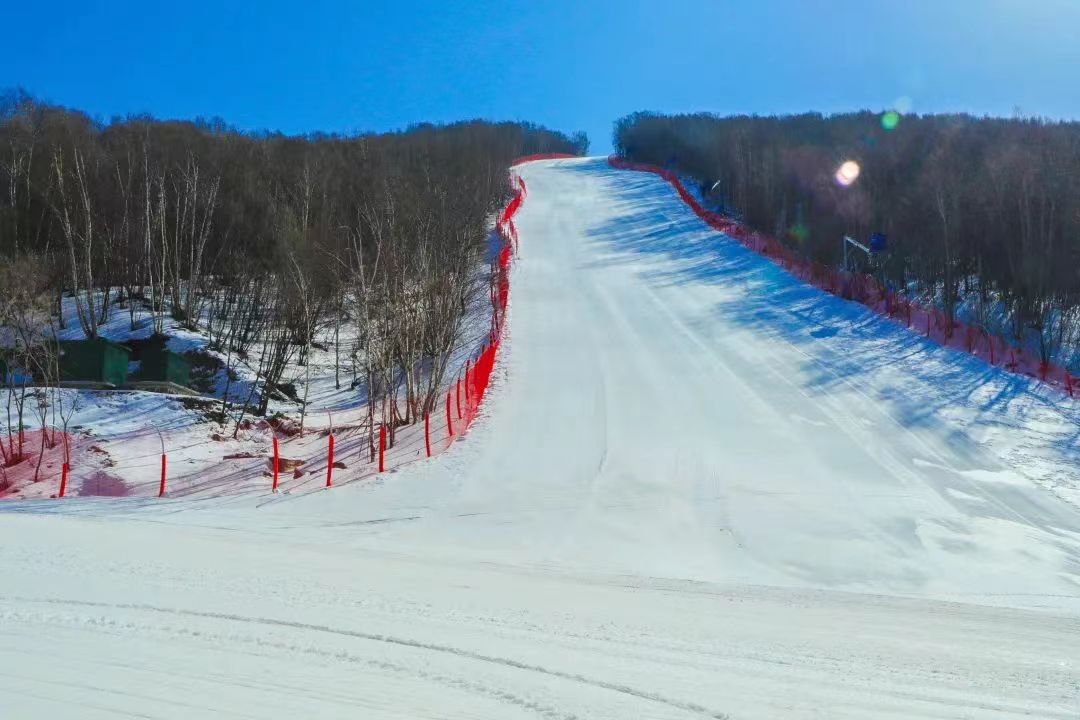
xmin=0 ymin=91 xmax=588 ymax=436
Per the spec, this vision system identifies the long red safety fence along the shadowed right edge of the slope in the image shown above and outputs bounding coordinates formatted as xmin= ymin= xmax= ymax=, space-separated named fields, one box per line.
xmin=608 ymin=155 xmax=1077 ymax=397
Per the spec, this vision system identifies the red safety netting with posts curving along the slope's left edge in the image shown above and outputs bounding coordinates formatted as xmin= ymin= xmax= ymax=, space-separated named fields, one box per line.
xmin=19 ymin=168 xmax=527 ymax=502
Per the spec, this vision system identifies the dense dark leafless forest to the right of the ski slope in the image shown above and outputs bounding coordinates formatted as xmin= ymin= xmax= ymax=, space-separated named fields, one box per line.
xmin=613 ymin=111 xmax=1080 ymax=367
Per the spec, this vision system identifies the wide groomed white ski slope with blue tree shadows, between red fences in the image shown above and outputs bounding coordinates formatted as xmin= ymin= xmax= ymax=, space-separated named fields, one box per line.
xmin=6 ymin=159 xmax=1080 ymax=720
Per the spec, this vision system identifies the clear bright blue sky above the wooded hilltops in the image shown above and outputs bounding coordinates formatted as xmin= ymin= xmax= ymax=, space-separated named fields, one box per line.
xmin=8 ymin=0 xmax=1080 ymax=153
